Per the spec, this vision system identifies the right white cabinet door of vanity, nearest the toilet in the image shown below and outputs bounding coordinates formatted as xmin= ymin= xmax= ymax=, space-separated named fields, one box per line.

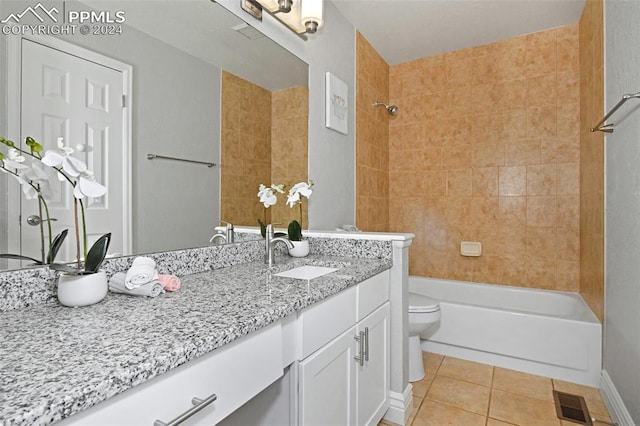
xmin=357 ymin=302 xmax=391 ymax=425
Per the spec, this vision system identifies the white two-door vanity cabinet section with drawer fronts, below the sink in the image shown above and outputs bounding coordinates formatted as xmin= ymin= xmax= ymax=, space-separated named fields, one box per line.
xmin=298 ymin=271 xmax=390 ymax=426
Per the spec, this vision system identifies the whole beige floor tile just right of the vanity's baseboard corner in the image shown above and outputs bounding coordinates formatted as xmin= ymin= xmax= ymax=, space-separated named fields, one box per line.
xmin=423 ymin=376 xmax=491 ymax=416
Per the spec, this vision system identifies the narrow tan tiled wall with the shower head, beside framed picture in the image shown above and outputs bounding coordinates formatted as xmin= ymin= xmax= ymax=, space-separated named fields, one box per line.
xmin=356 ymin=33 xmax=393 ymax=232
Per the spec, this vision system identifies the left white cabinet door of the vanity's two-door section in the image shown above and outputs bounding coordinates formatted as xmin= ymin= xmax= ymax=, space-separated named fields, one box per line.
xmin=299 ymin=326 xmax=358 ymax=426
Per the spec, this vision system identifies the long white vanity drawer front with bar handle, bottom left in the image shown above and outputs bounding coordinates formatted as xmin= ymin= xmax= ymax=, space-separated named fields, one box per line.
xmin=62 ymin=322 xmax=283 ymax=426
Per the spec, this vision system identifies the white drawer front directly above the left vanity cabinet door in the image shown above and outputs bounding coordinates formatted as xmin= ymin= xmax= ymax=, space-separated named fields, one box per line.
xmin=298 ymin=287 xmax=356 ymax=360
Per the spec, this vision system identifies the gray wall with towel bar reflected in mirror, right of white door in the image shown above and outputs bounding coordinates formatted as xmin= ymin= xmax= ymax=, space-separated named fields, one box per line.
xmin=3 ymin=1 xmax=221 ymax=253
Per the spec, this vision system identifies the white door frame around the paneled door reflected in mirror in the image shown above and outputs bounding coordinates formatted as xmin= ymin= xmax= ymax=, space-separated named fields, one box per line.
xmin=6 ymin=35 xmax=133 ymax=255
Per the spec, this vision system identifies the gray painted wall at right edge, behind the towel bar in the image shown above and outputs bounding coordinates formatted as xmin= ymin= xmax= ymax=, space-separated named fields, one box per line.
xmin=604 ymin=0 xmax=640 ymax=424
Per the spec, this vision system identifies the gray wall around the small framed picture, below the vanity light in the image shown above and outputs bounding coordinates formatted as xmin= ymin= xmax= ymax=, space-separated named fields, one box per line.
xmin=218 ymin=0 xmax=356 ymax=229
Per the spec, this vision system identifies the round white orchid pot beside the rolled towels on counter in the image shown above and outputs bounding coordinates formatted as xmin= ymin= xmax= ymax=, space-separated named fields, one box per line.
xmin=58 ymin=271 xmax=109 ymax=307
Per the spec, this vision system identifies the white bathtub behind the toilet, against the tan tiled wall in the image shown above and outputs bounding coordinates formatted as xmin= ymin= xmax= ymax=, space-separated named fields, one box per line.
xmin=409 ymin=276 xmax=602 ymax=386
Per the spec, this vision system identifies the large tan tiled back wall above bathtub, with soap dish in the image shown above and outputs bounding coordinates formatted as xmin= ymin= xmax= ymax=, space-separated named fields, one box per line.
xmin=389 ymin=25 xmax=580 ymax=291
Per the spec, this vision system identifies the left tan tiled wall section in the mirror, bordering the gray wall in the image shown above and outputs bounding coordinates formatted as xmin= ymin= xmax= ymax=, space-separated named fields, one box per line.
xmin=220 ymin=71 xmax=271 ymax=226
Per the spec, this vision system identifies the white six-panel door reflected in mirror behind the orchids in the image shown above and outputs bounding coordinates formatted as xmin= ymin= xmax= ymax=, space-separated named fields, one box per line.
xmin=21 ymin=39 xmax=126 ymax=261
